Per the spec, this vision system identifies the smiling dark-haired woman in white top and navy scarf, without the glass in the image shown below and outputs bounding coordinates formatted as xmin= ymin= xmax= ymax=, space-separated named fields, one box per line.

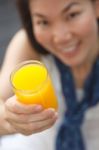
xmin=0 ymin=0 xmax=99 ymax=150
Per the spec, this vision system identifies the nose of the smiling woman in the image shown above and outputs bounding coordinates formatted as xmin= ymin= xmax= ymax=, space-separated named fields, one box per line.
xmin=53 ymin=26 xmax=72 ymax=44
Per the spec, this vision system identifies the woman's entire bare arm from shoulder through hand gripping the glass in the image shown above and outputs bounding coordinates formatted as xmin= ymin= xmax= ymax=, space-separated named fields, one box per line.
xmin=0 ymin=30 xmax=57 ymax=135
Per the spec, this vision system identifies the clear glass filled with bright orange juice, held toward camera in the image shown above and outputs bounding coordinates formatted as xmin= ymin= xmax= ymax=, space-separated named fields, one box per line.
xmin=10 ymin=60 xmax=58 ymax=110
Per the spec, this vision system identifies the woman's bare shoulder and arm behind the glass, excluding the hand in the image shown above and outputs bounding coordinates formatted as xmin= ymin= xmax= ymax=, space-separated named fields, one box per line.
xmin=0 ymin=30 xmax=39 ymax=100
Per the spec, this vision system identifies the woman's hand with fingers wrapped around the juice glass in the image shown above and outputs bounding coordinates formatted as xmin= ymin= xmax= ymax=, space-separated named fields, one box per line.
xmin=5 ymin=96 xmax=57 ymax=135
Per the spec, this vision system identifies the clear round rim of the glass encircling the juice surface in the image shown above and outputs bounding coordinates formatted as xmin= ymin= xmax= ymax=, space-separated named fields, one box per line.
xmin=10 ymin=60 xmax=48 ymax=94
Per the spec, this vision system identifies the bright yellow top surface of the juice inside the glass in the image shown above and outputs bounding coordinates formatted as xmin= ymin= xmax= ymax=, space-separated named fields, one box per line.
xmin=13 ymin=64 xmax=47 ymax=91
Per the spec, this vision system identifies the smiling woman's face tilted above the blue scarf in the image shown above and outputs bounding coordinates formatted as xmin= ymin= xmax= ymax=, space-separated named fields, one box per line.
xmin=30 ymin=0 xmax=98 ymax=67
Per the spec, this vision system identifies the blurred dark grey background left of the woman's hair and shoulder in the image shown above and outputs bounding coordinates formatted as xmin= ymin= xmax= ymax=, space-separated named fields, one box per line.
xmin=0 ymin=0 xmax=21 ymax=66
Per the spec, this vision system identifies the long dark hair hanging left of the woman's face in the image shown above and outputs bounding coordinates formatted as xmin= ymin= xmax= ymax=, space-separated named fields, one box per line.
xmin=16 ymin=0 xmax=48 ymax=54
